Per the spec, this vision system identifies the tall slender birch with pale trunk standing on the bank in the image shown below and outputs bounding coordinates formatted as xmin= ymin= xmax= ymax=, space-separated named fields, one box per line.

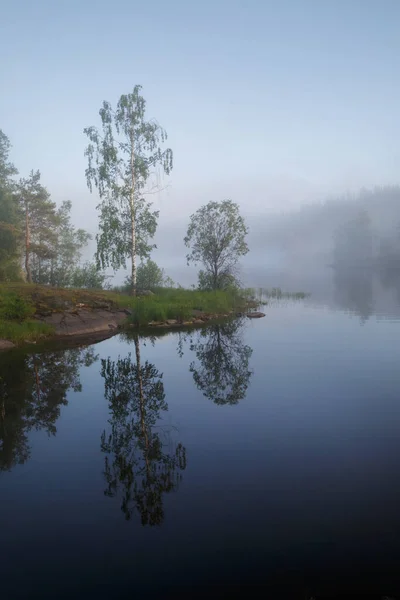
xmin=84 ymin=85 xmax=172 ymax=294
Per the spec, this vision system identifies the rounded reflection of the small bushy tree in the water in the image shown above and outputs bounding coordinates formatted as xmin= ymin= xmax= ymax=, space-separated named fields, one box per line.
xmin=185 ymin=320 xmax=253 ymax=405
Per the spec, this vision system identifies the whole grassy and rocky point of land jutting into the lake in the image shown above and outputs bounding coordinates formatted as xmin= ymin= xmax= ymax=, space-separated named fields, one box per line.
xmin=0 ymin=283 xmax=264 ymax=351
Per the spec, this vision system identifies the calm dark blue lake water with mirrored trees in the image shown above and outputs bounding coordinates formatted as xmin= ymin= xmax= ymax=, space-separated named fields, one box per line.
xmin=0 ymin=302 xmax=400 ymax=600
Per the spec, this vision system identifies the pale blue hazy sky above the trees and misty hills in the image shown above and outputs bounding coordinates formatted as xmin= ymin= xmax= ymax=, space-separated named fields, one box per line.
xmin=0 ymin=0 xmax=400 ymax=284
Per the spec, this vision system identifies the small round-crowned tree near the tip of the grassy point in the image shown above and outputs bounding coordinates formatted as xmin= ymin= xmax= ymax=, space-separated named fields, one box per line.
xmin=184 ymin=200 xmax=249 ymax=290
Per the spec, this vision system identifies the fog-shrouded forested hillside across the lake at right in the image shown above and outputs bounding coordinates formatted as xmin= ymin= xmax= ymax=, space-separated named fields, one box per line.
xmin=255 ymin=186 xmax=400 ymax=268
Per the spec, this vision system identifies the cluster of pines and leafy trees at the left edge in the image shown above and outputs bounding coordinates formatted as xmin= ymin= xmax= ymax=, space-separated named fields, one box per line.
xmin=0 ymin=130 xmax=106 ymax=288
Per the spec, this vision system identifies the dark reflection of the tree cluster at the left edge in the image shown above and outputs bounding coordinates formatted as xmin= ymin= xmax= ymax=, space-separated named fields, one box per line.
xmin=0 ymin=348 xmax=98 ymax=471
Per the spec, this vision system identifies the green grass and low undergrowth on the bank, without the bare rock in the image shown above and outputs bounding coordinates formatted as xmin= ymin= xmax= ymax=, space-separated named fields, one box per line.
xmin=0 ymin=283 xmax=245 ymax=344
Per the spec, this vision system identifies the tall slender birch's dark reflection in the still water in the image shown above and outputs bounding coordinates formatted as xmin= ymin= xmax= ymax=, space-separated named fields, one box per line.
xmin=101 ymin=337 xmax=186 ymax=525
